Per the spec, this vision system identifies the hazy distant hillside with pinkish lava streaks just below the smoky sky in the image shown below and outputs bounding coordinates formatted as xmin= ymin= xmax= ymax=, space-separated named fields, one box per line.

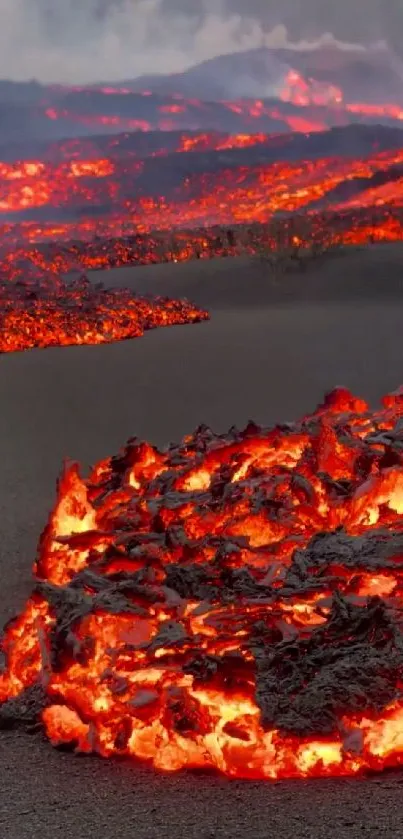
xmin=0 ymin=67 xmax=403 ymax=149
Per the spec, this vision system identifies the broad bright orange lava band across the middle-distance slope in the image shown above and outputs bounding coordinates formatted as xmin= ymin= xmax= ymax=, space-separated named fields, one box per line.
xmin=0 ymin=135 xmax=403 ymax=236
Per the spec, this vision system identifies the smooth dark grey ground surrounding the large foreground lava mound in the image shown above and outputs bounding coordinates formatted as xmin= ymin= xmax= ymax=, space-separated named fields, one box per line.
xmin=0 ymin=246 xmax=403 ymax=839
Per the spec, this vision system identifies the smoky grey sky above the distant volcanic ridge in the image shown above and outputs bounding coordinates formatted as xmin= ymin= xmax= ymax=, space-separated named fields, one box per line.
xmin=0 ymin=0 xmax=403 ymax=84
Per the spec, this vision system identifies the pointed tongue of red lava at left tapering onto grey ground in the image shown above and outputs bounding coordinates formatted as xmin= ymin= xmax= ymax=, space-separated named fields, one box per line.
xmin=0 ymin=272 xmax=208 ymax=353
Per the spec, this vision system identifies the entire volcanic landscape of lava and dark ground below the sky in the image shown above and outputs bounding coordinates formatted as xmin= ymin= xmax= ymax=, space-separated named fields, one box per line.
xmin=0 ymin=36 xmax=403 ymax=839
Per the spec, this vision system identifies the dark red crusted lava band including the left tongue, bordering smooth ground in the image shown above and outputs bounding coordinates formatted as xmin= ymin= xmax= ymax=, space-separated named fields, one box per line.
xmin=0 ymin=199 xmax=403 ymax=352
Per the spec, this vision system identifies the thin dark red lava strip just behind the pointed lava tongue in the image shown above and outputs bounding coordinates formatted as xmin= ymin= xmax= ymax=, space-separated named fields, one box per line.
xmin=0 ymin=205 xmax=403 ymax=290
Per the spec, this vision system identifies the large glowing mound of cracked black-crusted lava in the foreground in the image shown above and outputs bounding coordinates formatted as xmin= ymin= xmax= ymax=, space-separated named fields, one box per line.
xmin=0 ymin=388 xmax=403 ymax=779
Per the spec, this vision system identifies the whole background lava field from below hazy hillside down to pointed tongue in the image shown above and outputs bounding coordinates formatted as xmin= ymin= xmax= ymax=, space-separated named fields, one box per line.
xmin=0 ymin=119 xmax=403 ymax=352
